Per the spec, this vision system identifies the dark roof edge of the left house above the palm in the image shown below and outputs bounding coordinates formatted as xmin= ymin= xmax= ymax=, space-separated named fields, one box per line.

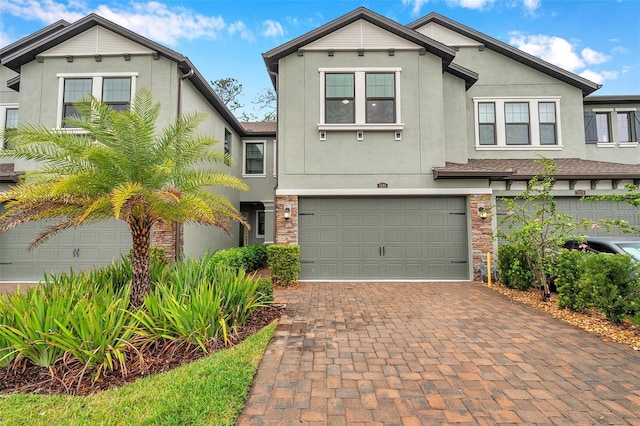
xmin=0 ymin=13 xmax=247 ymax=136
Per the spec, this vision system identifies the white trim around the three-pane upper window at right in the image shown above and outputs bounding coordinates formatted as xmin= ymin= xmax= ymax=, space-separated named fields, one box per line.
xmin=473 ymin=96 xmax=563 ymax=151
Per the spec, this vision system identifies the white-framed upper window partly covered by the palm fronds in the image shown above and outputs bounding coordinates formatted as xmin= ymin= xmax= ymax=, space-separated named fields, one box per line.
xmin=56 ymin=72 xmax=138 ymax=129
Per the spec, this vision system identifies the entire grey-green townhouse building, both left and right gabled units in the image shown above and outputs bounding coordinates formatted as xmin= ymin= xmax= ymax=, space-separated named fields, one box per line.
xmin=0 ymin=7 xmax=640 ymax=281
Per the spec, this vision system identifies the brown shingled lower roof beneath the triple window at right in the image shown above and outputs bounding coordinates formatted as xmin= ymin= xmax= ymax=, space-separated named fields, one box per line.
xmin=433 ymin=158 xmax=640 ymax=180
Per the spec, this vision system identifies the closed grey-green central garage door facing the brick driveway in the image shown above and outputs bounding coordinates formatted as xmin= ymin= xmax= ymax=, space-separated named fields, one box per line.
xmin=298 ymin=197 xmax=469 ymax=280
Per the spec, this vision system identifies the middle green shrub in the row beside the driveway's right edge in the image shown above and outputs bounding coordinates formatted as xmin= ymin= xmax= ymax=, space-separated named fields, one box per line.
xmin=552 ymin=250 xmax=593 ymax=312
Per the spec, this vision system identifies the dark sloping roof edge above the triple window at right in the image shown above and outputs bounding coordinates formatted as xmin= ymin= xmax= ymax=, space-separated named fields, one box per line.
xmin=407 ymin=13 xmax=602 ymax=96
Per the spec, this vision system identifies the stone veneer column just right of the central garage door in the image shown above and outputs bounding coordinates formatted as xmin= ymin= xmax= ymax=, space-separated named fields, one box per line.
xmin=469 ymin=195 xmax=495 ymax=280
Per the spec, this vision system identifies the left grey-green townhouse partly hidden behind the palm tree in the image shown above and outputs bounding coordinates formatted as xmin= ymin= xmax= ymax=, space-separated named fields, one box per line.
xmin=0 ymin=14 xmax=275 ymax=281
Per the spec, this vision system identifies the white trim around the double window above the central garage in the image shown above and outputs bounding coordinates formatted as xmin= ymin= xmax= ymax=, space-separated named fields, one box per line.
xmin=318 ymin=67 xmax=404 ymax=130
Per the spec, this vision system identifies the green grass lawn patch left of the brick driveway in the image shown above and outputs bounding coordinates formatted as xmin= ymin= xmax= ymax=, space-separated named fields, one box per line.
xmin=0 ymin=324 xmax=275 ymax=426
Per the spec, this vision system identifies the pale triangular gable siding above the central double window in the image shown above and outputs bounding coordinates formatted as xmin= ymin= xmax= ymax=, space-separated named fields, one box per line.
xmin=304 ymin=19 xmax=420 ymax=50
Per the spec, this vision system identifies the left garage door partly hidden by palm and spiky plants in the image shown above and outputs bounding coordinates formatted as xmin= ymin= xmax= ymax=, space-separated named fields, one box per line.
xmin=0 ymin=220 xmax=131 ymax=281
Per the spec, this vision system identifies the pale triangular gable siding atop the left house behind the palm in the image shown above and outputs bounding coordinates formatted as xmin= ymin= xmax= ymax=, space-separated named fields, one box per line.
xmin=40 ymin=26 xmax=152 ymax=57
